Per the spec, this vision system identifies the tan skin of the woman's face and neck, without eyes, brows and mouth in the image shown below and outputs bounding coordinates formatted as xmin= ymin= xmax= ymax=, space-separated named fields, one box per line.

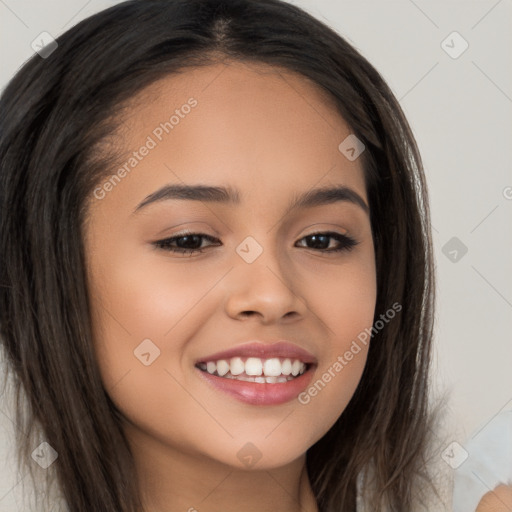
xmin=85 ymin=62 xmax=376 ymax=512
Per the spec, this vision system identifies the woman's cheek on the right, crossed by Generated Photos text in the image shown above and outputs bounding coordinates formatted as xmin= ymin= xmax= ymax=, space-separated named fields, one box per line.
xmin=292 ymin=252 xmax=377 ymax=443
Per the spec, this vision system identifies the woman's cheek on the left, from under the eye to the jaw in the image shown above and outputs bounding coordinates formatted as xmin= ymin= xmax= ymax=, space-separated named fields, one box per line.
xmin=86 ymin=251 xmax=218 ymax=443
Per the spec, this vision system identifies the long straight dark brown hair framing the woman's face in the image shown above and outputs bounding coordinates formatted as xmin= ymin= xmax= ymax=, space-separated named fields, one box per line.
xmin=0 ymin=0 xmax=434 ymax=512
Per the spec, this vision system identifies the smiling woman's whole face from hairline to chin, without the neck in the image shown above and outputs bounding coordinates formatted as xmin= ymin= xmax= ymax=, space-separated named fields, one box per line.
xmin=85 ymin=63 xmax=376 ymax=469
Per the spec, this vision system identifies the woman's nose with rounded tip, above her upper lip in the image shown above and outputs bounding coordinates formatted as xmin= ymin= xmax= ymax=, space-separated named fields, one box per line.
xmin=225 ymin=251 xmax=307 ymax=325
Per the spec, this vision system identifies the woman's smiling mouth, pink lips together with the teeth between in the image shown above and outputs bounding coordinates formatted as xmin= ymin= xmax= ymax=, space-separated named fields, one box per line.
xmin=195 ymin=341 xmax=317 ymax=405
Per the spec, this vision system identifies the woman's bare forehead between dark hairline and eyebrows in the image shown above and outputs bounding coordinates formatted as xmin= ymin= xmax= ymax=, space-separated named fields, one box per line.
xmin=93 ymin=62 xmax=366 ymax=214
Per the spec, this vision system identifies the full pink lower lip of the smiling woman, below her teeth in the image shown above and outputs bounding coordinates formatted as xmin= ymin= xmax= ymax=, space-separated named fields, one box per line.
xmin=197 ymin=367 xmax=314 ymax=405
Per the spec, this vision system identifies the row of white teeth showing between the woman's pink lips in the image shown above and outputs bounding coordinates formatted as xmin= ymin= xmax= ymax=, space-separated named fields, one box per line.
xmin=198 ymin=357 xmax=306 ymax=384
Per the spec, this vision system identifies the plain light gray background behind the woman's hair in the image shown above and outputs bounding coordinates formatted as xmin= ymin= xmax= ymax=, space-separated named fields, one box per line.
xmin=0 ymin=0 xmax=512 ymax=512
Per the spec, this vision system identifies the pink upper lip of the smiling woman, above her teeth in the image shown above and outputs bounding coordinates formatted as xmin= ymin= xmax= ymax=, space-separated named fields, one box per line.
xmin=196 ymin=340 xmax=317 ymax=364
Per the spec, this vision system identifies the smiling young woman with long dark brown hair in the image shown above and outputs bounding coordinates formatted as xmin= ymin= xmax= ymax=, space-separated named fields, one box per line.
xmin=0 ymin=0 xmax=440 ymax=512
